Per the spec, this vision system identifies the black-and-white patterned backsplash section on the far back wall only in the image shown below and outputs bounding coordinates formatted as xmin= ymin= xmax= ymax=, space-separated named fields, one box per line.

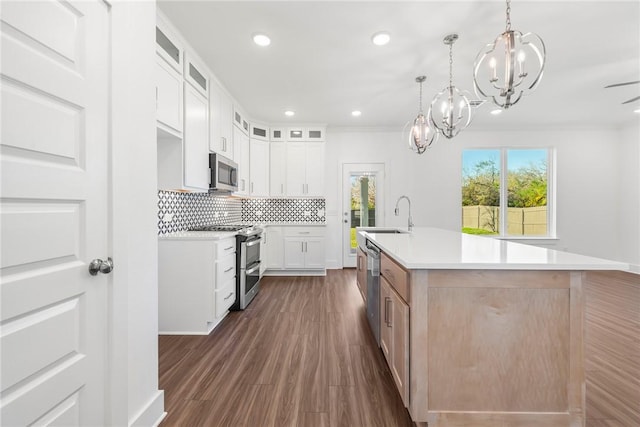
xmin=242 ymin=199 xmax=326 ymax=224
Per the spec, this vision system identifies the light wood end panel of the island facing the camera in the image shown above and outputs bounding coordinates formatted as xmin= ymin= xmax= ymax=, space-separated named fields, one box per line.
xmin=409 ymin=270 xmax=585 ymax=427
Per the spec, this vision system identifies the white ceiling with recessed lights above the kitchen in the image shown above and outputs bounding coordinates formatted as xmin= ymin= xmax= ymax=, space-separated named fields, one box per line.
xmin=158 ymin=0 xmax=640 ymax=129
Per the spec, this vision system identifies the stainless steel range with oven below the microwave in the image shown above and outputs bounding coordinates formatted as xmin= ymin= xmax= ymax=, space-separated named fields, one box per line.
xmin=191 ymin=225 xmax=263 ymax=310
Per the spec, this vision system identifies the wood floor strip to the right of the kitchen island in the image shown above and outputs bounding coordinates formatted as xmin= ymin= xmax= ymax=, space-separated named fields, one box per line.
xmin=585 ymin=271 xmax=640 ymax=426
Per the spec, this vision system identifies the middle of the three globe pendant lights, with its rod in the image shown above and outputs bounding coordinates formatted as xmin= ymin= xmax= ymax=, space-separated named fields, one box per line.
xmin=429 ymin=34 xmax=471 ymax=139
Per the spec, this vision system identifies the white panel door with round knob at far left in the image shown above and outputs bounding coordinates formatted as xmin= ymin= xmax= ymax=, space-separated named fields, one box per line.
xmin=0 ymin=0 xmax=111 ymax=426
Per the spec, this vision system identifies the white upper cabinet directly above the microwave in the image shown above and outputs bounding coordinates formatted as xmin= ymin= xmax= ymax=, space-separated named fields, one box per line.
xmin=209 ymin=79 xmax=234 ymax=160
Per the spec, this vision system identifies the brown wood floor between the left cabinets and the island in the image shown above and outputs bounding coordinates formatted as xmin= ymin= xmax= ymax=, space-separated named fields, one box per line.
xmin=160 ymin=270 xmax=412 ymax=427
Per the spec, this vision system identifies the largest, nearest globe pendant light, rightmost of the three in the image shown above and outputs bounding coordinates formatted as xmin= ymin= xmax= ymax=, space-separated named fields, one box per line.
xmin=473 ymin=0 xmax=546 ymax=109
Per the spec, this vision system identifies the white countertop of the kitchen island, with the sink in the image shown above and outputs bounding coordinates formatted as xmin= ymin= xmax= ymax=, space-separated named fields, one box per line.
xmin=359 ymin=227 xmax=630 ymax=271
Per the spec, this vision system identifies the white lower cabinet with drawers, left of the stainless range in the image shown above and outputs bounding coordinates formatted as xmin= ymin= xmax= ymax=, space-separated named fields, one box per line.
xmin=158 ymin=237 xmax=236 ymax=335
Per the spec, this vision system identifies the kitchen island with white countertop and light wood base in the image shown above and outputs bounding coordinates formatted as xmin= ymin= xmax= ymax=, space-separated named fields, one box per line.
xmin=365 ymin=228 xmax=629 ymax=427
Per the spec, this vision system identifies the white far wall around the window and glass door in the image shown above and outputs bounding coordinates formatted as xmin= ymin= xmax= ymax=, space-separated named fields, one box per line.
xmin=326 ymin=122 xmax=640 ymax=268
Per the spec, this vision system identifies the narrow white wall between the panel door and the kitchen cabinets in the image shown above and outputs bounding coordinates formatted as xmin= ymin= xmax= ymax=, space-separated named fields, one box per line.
xmin=111 ymin=1 xmax=164 ymax=426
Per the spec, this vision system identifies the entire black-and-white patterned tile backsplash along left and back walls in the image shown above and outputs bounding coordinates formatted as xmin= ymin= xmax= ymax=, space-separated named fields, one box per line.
xmin=158 ymin=190 xmax=326 ymax=234
